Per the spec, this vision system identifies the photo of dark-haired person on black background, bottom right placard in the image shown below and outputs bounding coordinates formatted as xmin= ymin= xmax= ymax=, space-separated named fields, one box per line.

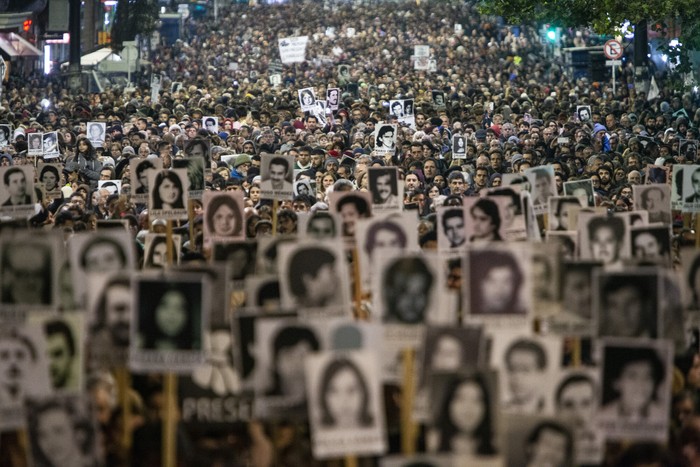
xmin=598 ymin=339 xmax=672 ymax=441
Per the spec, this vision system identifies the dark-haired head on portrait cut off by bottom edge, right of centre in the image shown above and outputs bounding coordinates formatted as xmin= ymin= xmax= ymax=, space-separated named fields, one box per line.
xmin=525 ymin=421 xmax=574 ymax=466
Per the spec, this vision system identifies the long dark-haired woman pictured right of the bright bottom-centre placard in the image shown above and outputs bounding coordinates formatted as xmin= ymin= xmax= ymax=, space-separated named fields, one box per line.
xmin=436 ymin=373 xmax=496 ymax=456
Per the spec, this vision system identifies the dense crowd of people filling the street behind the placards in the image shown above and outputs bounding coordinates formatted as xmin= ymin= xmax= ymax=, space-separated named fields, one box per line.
xmin=0 ymin=1 xmax=700 ymax=466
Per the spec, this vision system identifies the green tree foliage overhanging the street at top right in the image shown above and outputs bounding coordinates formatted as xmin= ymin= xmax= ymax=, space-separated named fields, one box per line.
xmin=478 ymin=0 xmax=700 ymax=73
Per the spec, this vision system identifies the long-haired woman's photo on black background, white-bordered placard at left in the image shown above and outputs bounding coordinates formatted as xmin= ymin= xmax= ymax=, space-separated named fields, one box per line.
xmin=139 ymin=283 xmax=201 ymax=350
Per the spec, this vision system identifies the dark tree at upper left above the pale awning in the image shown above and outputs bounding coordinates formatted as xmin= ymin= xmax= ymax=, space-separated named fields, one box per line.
xmin=112 ymin=0 xmax=158 ymax=51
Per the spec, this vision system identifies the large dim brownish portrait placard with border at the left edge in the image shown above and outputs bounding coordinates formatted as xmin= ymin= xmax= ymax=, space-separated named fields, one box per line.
xmin=0 ymin=236 xmax=59 ymax=309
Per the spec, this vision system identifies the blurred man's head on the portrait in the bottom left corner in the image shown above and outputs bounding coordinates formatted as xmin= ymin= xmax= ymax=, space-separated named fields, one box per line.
xmin=27 ymin=398 xmax=95 ymax=467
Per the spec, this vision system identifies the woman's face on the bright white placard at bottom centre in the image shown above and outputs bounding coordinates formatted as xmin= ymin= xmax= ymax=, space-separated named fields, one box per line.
xmin=325 ymin=368 xmax=365 ymax=428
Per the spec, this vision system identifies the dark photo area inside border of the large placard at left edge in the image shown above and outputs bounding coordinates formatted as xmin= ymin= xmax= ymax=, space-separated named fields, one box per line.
xmin=0 ymin=240 xmax=53 ymax=305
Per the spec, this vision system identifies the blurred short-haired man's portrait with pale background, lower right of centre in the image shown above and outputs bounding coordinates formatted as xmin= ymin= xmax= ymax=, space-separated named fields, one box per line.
xmin=491 ymin=329 xmax=562 ymax=414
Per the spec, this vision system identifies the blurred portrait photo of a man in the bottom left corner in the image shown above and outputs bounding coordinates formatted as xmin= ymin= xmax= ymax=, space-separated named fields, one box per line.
xmin=26 ymin=395 xmax=101 ymax=467
